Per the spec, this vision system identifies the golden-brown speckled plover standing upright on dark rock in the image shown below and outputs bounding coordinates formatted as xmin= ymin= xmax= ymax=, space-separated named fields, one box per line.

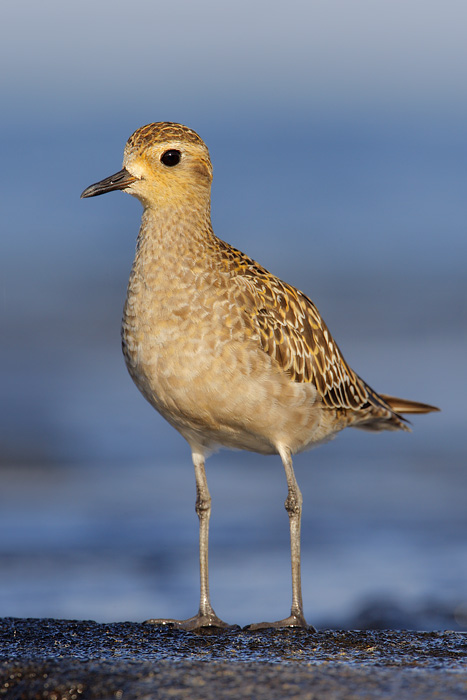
xmin=81 ymin=122 xmax=439 ymax=631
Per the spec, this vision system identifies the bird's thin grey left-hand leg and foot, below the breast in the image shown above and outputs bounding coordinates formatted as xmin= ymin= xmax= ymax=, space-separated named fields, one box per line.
xmin=146 ymin=449 xmax=238 ymax=631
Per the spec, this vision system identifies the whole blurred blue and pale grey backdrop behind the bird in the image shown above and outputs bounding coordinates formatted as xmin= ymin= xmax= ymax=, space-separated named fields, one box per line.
xmin=0 ymin=0 xmax=467 ymax=629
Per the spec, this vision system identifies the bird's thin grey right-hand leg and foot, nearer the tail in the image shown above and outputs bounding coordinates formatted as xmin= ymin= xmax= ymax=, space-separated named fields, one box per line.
xmin=245 ymin=446 xmax=316 ymax=632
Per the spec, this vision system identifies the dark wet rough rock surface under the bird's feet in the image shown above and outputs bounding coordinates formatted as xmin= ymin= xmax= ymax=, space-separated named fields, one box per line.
xmin=0 ymin=618 xmax=467 ymax=700
